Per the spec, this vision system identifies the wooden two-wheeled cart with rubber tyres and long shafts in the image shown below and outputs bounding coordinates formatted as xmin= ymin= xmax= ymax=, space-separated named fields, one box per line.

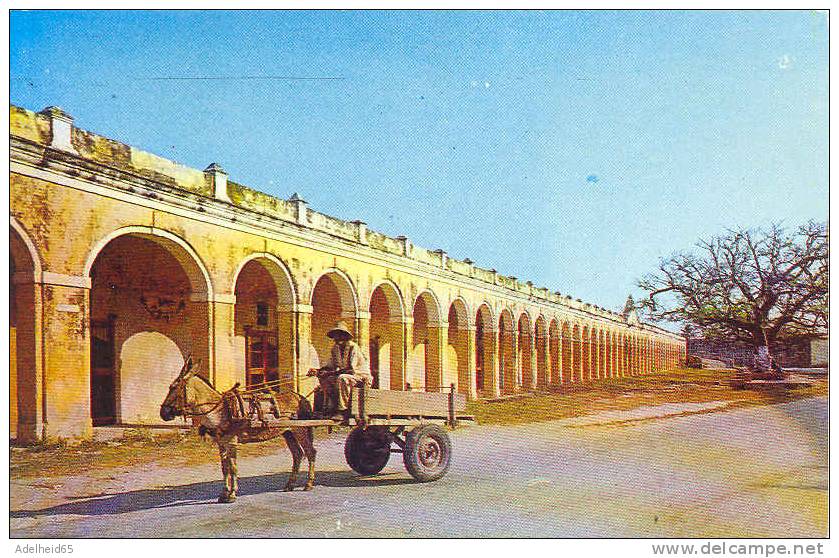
xmin=246 ymin=385 xmax=474 ymax=482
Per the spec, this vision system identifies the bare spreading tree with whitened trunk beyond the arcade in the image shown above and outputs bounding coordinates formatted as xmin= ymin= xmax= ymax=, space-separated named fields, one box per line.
xmin=638 ymin=221 xmax=829 ymax=370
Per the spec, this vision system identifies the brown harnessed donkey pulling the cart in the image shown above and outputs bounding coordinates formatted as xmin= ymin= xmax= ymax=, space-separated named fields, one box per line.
xmin=160 ymin=356 xmax=317 ymax=504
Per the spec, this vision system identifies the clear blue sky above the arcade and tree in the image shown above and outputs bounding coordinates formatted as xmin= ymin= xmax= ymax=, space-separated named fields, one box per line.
xmin=10 ymin=11 xmax=828 ymax=320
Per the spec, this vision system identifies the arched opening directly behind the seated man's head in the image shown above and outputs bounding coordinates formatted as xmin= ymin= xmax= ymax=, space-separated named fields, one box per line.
xmin=311 ymin=271 xmax=358 ymax=368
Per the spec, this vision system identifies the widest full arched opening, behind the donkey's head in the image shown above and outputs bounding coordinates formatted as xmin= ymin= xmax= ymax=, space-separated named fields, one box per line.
xmin=89 ymin=232 xmax=211 ymax=426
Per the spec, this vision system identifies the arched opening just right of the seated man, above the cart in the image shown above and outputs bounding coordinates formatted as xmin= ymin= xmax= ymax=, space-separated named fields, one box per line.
xmin=370 ymin=283 xmax=405 ymax=391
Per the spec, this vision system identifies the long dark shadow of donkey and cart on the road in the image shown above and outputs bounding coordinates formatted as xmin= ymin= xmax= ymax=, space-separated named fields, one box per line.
xmin=9 ymin=471 xmax=416 ymax=519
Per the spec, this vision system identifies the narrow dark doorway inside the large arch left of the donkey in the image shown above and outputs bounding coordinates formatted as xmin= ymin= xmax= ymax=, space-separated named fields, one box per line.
xmin=90 ymin=315 xmax=117 ymax=426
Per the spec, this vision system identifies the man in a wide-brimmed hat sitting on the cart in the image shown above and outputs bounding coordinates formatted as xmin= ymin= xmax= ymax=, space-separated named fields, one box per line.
xmin=309 ymin=322 xmax=373 ymax=420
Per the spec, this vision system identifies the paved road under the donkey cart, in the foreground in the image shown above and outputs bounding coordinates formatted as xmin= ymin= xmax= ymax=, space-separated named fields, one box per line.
xmin=11 ymin=398 xmax=828 ymax=537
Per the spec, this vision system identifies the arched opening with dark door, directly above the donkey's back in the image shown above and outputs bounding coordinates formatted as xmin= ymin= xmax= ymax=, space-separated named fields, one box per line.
xmin=233 ymin=257 xmax=295 ymax=390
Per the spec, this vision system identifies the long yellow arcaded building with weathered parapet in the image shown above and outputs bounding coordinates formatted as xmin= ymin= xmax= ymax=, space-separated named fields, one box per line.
xmin=9 ymin=106 xmax=685 ymax=441
